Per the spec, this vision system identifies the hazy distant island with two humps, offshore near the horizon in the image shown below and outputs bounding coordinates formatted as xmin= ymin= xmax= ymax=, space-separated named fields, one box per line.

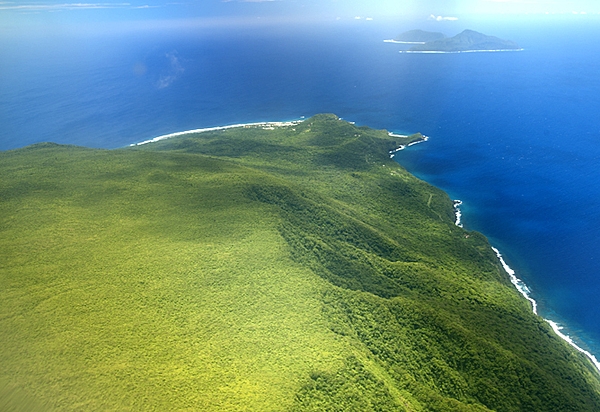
xmin=391 ymin=30 xmax=521 ymax=53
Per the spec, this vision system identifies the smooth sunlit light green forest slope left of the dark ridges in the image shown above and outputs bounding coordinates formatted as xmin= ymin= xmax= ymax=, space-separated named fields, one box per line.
xmin=0 ymin=147 xmax=356 ymax=410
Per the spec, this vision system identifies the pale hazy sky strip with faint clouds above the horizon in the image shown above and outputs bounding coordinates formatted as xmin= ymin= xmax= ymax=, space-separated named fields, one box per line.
xmin=0 ymin=0 xmax=600 ymax=30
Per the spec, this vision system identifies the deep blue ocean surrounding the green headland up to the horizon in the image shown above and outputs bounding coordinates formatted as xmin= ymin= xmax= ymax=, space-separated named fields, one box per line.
xmin=0 ymin=16 xmax=600 ymax=355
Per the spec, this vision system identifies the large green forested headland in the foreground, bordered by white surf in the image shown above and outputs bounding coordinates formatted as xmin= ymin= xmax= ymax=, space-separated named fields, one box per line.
xmin=0 ymin=114 xmax=600 ymax=412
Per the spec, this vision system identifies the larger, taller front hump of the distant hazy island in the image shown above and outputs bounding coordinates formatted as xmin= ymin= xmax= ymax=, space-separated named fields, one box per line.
xmin=408 ymin=30 xmax=520 ymax=53
